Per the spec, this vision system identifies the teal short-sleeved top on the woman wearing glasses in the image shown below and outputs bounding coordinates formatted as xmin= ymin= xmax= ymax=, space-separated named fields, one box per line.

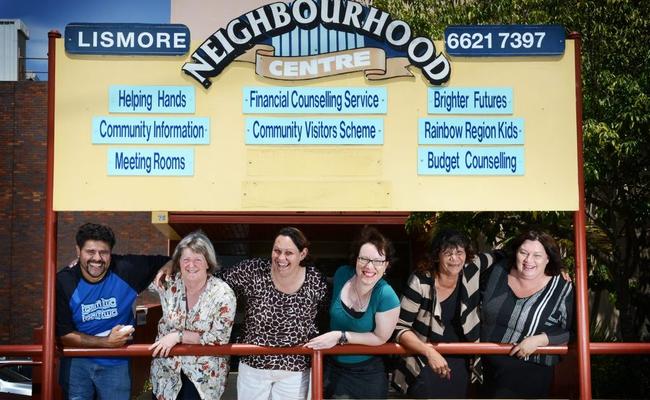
xmin=330 ymin=265 xmax=400 ymax=363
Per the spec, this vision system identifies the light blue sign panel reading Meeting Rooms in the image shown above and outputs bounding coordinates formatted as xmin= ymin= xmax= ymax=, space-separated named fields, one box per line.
xmin=108 ymin=148 xmax=194 ymax=176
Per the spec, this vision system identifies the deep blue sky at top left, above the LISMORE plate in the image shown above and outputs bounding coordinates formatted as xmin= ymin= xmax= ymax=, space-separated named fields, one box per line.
xmin=0 ymin=0 xmax=171 ymax=80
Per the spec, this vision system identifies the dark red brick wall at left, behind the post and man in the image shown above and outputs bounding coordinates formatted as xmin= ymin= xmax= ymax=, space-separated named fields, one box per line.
xmin=0 ymin=81 xmax=167 ymax=344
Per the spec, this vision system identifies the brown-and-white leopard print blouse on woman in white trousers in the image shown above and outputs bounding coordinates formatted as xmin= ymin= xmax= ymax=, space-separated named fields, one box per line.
xmin=218 ymin=258 xmax=327 ymax=371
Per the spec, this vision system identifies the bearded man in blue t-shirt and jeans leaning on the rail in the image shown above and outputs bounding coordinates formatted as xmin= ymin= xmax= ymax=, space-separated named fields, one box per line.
xmin=56 ymin=223 xmax=169 ymax=400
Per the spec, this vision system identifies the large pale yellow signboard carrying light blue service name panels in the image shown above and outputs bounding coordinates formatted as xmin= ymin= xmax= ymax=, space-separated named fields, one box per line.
xmin=54 ymin=29 xmax=578 ymax=211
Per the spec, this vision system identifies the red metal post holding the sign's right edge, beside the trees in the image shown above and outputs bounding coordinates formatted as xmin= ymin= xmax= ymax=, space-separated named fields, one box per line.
xmin=569 ymin=32 xmax=591 ymax=400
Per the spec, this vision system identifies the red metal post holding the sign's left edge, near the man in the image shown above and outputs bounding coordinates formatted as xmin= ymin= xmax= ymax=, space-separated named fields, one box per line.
xmin=41 ymin=31 xmax=61 ymax=399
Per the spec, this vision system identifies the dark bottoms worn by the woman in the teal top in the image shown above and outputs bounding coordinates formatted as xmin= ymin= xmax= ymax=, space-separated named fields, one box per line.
xmin=324 ymin=357 xmax=388 ymax=399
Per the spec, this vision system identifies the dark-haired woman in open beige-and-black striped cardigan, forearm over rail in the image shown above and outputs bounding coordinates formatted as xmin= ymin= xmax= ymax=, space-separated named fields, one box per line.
xmin=393 ymin=230 xmax=502 ymax=398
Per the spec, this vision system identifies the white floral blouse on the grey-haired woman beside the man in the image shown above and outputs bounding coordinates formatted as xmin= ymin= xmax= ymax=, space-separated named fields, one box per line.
xmin=151 ymin=274 xmax=237 ymax=400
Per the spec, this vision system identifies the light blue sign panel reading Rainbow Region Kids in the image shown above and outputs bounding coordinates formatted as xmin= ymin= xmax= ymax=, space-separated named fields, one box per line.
xmin=418 ymin=118 xmax=524 ymax=144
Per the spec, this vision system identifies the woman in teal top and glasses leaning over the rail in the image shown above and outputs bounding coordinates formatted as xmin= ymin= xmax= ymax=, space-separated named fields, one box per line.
xmin=305 ymin=227 xmax=399 ymax=399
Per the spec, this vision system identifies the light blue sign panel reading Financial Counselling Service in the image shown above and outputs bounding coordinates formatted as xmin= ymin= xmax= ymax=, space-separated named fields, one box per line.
xmin=242 ymin=87 xmax=388 ymax=114
